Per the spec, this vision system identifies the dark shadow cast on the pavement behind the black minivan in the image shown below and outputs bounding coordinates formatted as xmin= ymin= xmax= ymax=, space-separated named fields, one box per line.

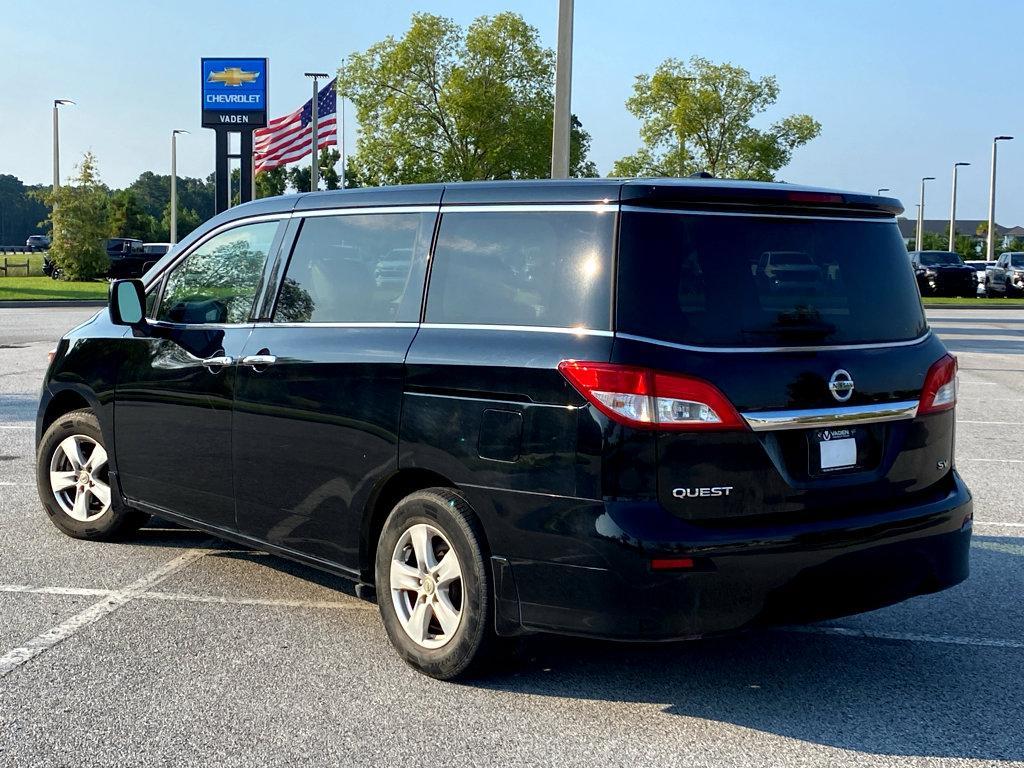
xmin=467 ymin=538 xmax=1024 ymax=762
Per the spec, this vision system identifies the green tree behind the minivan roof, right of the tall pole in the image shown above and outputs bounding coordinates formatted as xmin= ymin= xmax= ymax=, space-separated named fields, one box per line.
xmin=612 ymin=56 xmax=821 ymax=181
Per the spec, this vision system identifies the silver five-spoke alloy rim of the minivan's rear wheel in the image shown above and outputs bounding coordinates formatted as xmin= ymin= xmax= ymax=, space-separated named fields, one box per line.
xmin=390 ymin=523 xmax=464 ymax=649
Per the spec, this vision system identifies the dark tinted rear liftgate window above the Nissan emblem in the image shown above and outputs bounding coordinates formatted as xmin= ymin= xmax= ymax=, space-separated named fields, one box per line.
xmin=617 ymin=211 xmax=927 ymax=347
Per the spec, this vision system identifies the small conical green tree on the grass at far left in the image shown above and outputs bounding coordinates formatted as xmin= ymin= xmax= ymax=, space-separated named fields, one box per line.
xmin=45 ymin=153 xmax=110 ymax=281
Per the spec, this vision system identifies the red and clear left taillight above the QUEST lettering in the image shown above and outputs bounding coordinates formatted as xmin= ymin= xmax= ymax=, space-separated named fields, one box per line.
xmin=558 ymin=360 xmax=745 ymax=430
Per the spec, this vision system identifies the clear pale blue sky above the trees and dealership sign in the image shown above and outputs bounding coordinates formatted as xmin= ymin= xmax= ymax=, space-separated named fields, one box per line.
xmin=0 ymin=0 xmax=1024 ymax=224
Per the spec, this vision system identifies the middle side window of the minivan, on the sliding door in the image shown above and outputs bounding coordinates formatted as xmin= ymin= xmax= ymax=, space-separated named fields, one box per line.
xmin=273 ymin=213 xmax=435 ymax=323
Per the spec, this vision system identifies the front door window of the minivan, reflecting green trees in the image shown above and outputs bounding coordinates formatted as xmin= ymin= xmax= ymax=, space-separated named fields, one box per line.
xmin=157 ymin=221 xmax=278 ymax=324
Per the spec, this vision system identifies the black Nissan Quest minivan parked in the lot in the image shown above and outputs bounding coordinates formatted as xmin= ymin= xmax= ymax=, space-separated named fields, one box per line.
xmin=37 ymin=179 xmax=972 ymax=678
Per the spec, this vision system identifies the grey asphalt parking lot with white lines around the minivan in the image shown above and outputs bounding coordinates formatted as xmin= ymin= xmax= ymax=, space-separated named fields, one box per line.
xmin=0 ymin=308 xmax=1024 ymax=766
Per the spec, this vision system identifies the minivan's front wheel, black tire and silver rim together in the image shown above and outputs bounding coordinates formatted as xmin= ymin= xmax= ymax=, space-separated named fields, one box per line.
xmin=36 ymin=409 xmax=150 ymax=540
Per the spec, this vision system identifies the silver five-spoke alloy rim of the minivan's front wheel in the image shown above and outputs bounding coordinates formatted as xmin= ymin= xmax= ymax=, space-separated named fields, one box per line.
xmin=50 ymin=435 xmax=111 ymax=522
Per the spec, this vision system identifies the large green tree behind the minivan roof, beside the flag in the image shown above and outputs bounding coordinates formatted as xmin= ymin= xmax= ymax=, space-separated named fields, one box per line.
xmin=338 ymin=12 xmax=594 ymax=184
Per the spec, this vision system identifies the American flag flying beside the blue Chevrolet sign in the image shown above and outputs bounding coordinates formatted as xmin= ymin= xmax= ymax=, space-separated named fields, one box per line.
xmin=254 ymin=78 xmax=338 ymax=171
